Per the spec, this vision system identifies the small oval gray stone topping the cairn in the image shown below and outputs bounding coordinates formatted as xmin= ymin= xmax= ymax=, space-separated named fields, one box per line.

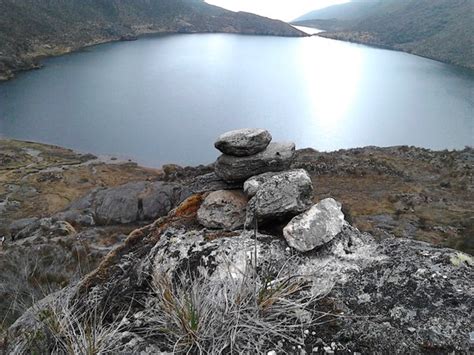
xmin=214 ymin=128 xmax=272 ymax=157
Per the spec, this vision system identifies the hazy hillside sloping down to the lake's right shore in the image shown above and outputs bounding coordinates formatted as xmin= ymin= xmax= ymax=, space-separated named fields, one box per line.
xmin=294 ymin=0 xmax=474 ymax=69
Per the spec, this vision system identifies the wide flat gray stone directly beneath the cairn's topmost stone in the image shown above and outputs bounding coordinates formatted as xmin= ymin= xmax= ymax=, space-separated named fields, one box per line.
xmin=215 ymin=143 xmax=295 ymax=181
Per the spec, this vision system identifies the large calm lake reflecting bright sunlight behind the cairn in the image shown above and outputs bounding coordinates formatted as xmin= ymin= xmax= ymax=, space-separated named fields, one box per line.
xmin=0 ymin=30 xmax=474 ymax=166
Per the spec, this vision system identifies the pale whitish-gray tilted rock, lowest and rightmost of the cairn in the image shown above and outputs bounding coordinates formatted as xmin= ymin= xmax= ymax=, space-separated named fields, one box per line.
xmin=283 ymin=198 xmax=345 ymax=252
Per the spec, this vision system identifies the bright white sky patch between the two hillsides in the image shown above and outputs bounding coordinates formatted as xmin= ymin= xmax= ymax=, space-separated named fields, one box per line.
xmin=206 ymin=0 xmax=349 ymax=21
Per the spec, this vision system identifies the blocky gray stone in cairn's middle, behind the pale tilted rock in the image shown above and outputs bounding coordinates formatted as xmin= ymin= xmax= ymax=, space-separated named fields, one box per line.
xmin=245 ymin=169 xmax=313 ymax=227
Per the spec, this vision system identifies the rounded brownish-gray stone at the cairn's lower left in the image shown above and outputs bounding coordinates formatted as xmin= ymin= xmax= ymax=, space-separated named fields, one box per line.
xmin=197 ymin=190 xmax=248 ymax=230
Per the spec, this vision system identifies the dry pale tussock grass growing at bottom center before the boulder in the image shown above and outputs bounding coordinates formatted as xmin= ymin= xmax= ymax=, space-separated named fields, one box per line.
xmin=146 ymin=263 xmax=319 ymax=354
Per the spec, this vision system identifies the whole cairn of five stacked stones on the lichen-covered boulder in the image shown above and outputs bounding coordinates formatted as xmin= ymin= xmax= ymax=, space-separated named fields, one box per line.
xmin=198 ymin=128 xmax=346 ymax=252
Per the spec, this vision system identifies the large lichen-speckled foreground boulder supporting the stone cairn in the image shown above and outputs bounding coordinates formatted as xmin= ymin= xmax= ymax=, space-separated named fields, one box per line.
xmin=8 ymin=223 xmax=474 ymax=354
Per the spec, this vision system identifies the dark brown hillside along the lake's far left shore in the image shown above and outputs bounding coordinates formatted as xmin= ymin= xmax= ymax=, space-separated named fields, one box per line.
xmin=0 ymin=0 xmax=304 ymax=80
